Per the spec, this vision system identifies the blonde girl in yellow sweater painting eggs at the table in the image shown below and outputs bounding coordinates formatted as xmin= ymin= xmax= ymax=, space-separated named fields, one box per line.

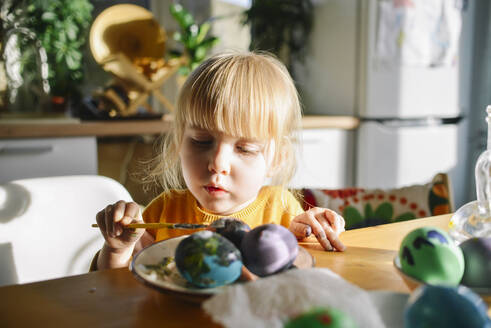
xmin=95 ymin=53 xmax=345 ymax=269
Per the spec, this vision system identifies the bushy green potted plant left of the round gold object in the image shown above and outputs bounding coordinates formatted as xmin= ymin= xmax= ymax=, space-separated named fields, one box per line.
xmin=25 ymin=0 xmax=93 ymax=107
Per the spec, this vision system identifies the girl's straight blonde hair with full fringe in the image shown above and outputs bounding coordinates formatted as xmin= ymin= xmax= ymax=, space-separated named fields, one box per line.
xmin=151 ymin=52 xmax=301 ymax=190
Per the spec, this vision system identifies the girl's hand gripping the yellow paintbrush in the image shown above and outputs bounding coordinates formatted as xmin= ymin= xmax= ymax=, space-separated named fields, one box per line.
xmin=96 ymin=200 xmax=145 ymax=252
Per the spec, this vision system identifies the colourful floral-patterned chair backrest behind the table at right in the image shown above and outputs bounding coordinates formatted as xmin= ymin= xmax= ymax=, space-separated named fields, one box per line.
xmin=302 ymin=173 xmax=453 ymax=229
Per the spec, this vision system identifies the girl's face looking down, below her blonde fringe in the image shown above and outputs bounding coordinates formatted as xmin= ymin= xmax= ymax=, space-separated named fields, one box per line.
xmin=179 ymin=126 xmax=274 ymax=215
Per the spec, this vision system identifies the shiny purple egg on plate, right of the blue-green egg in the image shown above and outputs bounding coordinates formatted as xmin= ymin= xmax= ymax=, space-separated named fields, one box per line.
xmin=240 ymin=224 xmax=298 ymax=277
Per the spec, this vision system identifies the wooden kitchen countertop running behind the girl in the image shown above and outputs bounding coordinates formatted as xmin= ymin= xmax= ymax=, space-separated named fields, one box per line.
xmin=0 ymin=115 xmax=359 ymax=138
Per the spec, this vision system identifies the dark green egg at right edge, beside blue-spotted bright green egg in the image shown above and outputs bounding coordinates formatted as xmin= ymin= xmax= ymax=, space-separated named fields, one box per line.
xmin=459 ymin=237 xmax=491 ymax=288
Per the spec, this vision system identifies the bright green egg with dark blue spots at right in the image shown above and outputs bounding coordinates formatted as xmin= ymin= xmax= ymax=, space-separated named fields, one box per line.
xmin=399 ymin=227 xmax=464 ymax=286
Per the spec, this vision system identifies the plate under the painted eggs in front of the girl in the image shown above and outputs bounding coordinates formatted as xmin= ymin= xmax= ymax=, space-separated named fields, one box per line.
xmin=130 ymin=235 xmax=315 ymax=298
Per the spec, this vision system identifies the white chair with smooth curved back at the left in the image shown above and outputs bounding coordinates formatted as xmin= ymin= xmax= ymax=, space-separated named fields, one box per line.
xmin=0 ymin=175 xmax=132 ymax=286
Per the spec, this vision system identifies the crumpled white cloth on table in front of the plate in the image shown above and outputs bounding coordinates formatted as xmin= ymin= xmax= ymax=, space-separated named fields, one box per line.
xmin=202 ymin=268 xmax=385 ymax=328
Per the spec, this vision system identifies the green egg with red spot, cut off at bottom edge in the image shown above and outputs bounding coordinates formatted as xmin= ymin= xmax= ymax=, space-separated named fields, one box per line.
xmin=284 ymin=308 xmax=357 ymax=328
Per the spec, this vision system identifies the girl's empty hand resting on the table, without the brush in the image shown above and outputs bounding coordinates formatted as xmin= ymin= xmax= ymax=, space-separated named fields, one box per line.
xmin=289 ymin=207 xmax=346 ymax=251
